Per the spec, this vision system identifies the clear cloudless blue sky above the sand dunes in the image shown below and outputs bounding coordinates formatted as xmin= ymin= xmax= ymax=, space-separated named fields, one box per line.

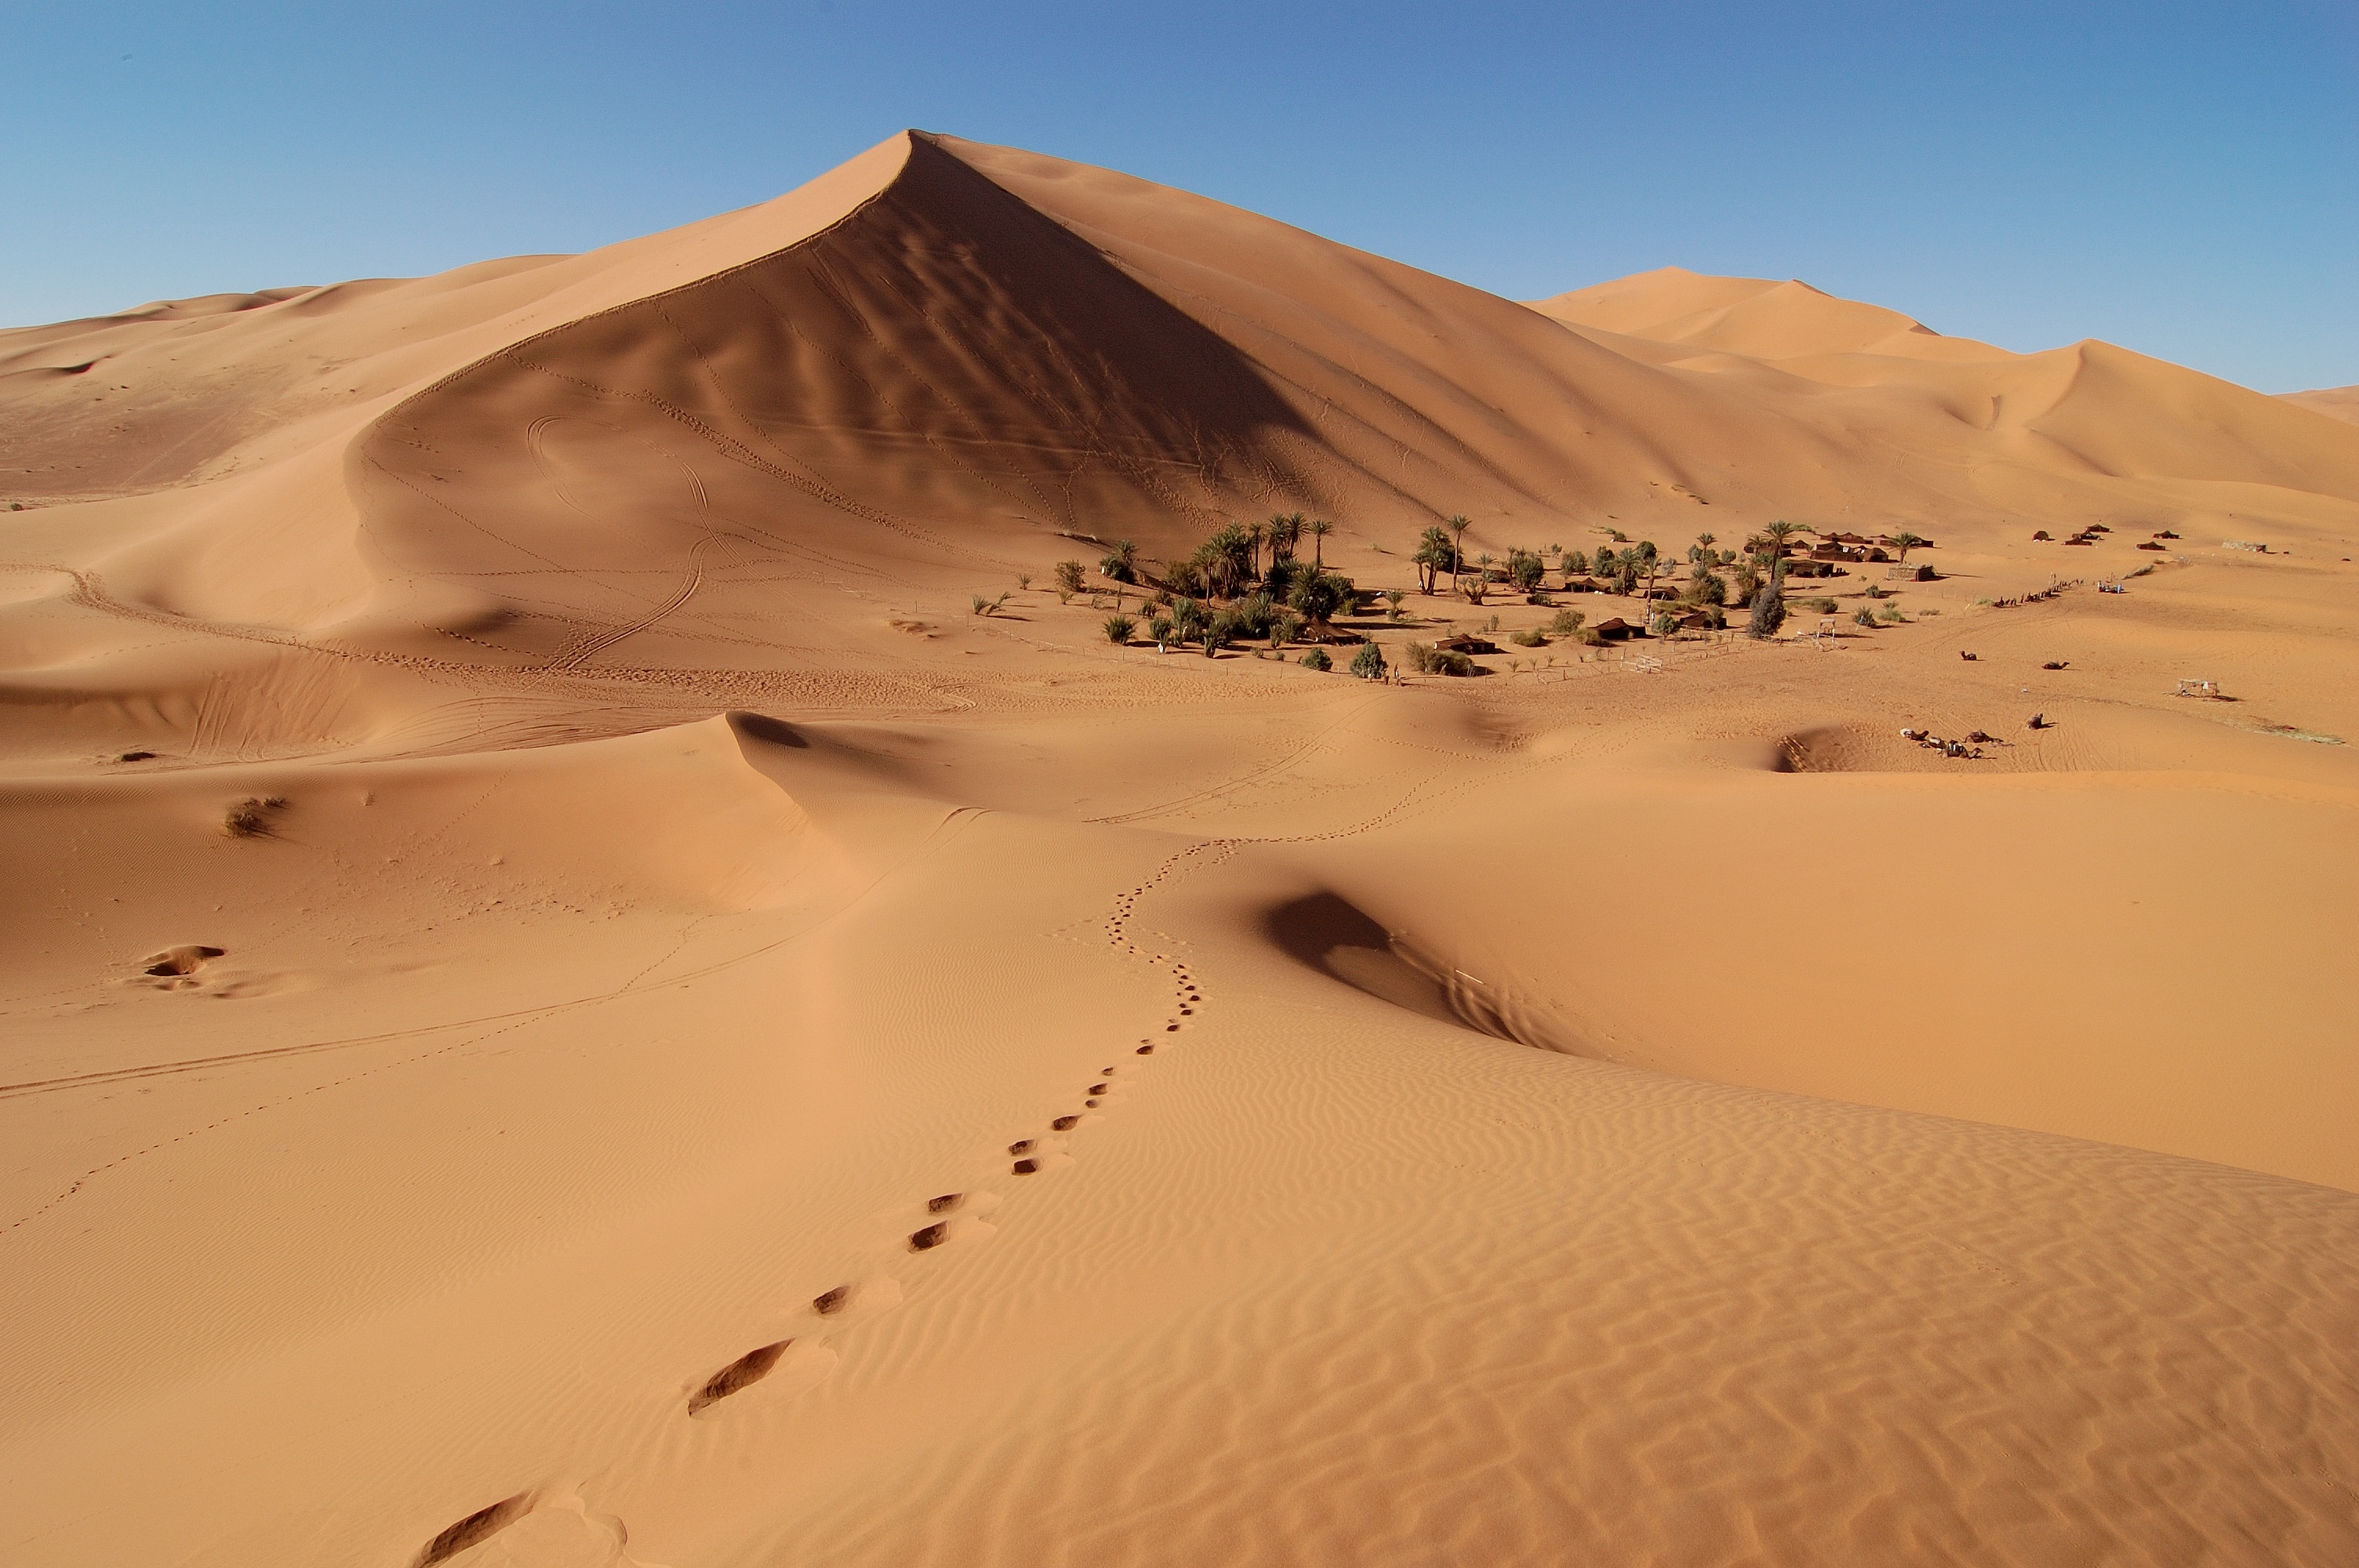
xmin=0 ymin=0 xmax=2359 ymax=391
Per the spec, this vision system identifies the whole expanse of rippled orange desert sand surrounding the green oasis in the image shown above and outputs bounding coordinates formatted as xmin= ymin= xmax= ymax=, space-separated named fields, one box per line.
xmin=0 ymin=132 xmax=2359 ymax=1568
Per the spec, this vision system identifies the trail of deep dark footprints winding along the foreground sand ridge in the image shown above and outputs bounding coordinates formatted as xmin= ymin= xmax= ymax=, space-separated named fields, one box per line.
xmin=413 ymin=840 xmax=1238 ymax=1568
